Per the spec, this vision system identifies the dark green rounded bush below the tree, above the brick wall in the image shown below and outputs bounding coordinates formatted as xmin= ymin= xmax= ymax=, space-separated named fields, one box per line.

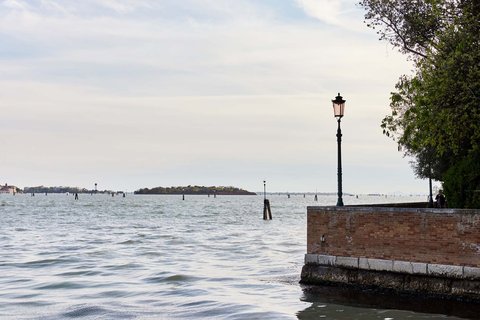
xmin=443 ymin=152 xmax=480 ymax=209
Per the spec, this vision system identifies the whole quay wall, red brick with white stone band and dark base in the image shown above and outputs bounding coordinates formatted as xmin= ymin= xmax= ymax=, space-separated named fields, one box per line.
xmin=301 ymin=205 xmax=480 ymax=302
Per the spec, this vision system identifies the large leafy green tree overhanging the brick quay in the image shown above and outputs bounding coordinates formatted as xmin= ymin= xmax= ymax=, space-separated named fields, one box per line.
xmin=360 ymin=0 xmax=480 ymax=206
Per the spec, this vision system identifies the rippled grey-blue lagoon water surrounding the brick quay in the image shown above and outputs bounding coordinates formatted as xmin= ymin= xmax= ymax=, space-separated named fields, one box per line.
xmin=0 ymin=194 xmax=478 ymax=320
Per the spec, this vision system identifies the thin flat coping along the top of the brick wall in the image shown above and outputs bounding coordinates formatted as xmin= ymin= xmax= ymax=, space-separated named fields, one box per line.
xmin=307 ymin=204 xmax=480 ymax=214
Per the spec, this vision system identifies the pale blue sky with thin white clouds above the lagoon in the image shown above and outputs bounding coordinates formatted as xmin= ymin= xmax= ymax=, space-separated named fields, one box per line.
xmin=0 ymin=0 xmax=436 ymax=194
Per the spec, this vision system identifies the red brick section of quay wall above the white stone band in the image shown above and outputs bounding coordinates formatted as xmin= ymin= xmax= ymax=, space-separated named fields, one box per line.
xmin=307 ymin=207 xmax=480 ymax=267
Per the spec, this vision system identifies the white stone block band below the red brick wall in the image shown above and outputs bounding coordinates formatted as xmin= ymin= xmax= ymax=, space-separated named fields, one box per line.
xmin=305 ymin=253 xmax=480 ymax=280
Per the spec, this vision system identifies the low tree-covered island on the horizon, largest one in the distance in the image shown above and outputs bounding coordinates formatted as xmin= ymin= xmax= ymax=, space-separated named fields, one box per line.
xmin=134 ymin=185 xmax=256 ymax=195
